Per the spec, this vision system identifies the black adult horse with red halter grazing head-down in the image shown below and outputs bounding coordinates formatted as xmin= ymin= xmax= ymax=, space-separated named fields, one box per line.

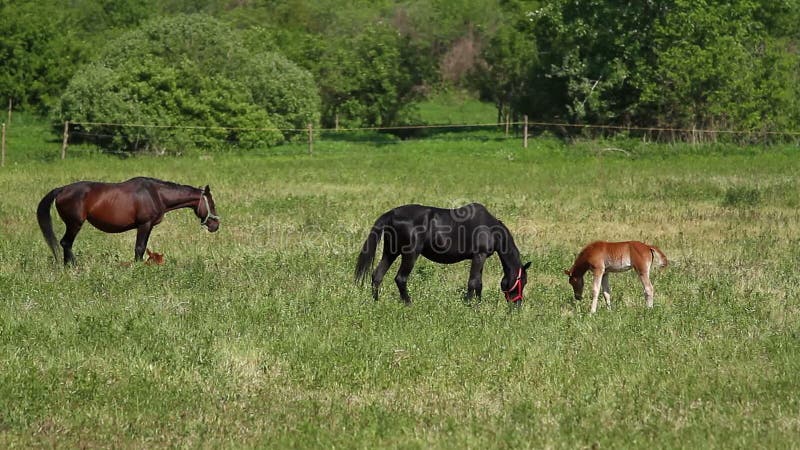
xmin=355 ymin=203 xmax=531 ymax=305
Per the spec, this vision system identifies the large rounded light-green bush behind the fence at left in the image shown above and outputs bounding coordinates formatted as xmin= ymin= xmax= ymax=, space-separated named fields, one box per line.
xmin=55 ymin=15 xmax=319 ymax=152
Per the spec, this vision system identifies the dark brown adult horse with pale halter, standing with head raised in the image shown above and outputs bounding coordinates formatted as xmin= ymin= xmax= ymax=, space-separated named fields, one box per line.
xmin=36 ymin=177 xmax=219 ymax=265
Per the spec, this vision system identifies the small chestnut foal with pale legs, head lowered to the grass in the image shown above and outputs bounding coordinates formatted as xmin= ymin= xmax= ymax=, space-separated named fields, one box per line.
xmin=564 ymin=241 xmax=669 ymax=313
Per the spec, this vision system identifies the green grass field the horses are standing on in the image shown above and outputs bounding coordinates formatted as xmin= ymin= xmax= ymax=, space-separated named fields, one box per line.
xmin=0 ymin=118 xmax=800 ymax=448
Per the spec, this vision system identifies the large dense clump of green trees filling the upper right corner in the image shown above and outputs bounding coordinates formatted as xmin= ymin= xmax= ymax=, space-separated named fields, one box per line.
xmin=481 ymin=0 xmax=800 ymax=137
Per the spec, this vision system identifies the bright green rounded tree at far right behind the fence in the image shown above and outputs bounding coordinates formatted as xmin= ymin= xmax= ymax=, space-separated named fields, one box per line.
xmin=641 ymin=0 xmax=798 ymax=134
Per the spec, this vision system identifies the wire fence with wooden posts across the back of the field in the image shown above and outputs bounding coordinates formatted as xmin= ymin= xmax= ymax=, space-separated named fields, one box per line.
xmin=0 ymin=116 xmax=800 ymax=166
